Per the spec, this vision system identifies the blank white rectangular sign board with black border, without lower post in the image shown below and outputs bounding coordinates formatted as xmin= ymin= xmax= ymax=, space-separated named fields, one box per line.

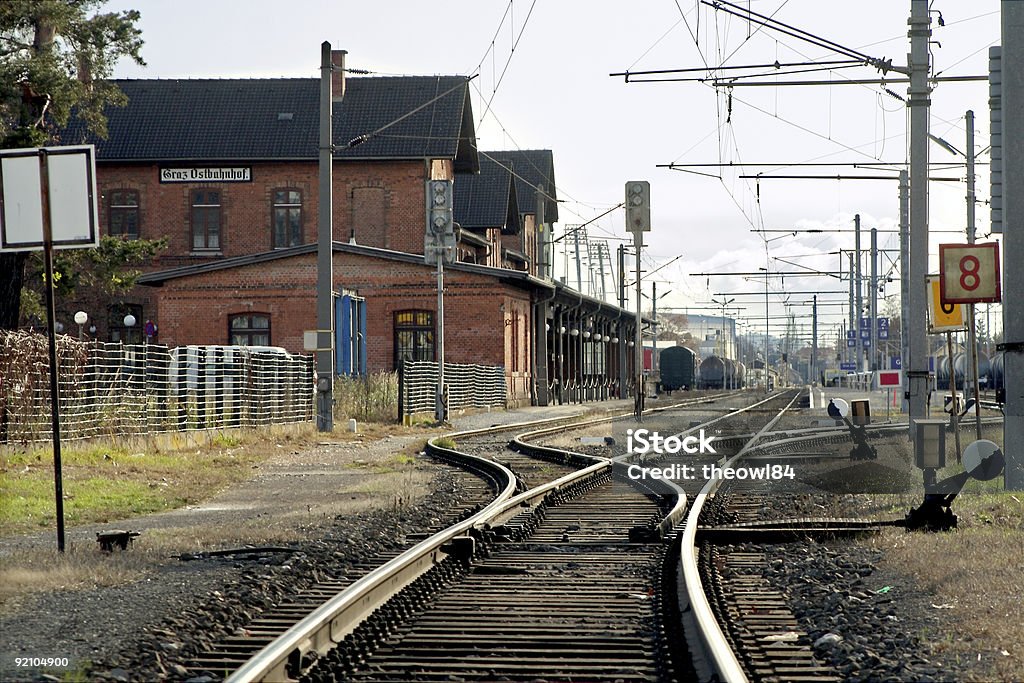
xmin=0 ymin=145 xmax=99 ymax=251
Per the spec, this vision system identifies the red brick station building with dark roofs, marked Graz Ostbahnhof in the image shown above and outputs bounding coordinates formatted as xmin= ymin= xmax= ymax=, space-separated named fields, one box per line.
xmin=62 ymin=58 xmax=632 ymax=403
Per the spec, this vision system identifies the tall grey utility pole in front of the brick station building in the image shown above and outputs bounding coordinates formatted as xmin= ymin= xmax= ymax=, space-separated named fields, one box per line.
xmin=316 ymin=41 xmax=335 ymax=432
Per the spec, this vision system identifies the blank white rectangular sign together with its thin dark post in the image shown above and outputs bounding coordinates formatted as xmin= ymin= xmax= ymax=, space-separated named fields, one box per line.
xmin=0 ymin=144 xmax=99 ymax=553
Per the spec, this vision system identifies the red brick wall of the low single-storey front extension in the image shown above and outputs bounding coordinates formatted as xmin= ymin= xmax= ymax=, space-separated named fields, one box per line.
xmin=153 ymin=248 xmax=531 ymax=401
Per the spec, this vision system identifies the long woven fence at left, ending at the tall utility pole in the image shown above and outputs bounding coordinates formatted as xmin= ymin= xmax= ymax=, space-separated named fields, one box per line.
xmin=0 ymin=332 xmax=313 ymax=443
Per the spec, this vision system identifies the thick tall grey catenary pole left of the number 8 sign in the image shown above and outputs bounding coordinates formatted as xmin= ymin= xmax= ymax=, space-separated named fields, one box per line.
xmin=904 ymin=0 xmax=933 ymax=439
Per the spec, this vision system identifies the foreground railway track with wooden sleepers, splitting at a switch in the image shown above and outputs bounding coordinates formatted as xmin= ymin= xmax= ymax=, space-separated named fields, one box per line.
xmin=199 ymin=393 xmax=905 ymax=682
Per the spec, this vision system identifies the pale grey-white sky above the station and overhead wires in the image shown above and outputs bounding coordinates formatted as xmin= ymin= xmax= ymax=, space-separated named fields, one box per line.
xmin=105 ymin=0 xmax=999 ymax=342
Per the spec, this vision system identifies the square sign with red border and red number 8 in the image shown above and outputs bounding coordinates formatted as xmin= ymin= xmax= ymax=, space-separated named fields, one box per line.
xmin=939 ymin=242 xmax=999 ymax=304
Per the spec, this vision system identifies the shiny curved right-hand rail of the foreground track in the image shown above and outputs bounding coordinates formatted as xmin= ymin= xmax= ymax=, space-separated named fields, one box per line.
xmin=678 ymin=393 xmax=800 ymax=683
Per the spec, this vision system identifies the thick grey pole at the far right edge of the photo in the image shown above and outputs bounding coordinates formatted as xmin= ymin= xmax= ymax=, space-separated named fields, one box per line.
xmin=1000 ymin=0 xmax=1024 ymax=490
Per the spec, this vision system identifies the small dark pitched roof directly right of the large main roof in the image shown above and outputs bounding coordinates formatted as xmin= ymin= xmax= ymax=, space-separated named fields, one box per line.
xmin=453 ymin=155 xmax=521 ymax=234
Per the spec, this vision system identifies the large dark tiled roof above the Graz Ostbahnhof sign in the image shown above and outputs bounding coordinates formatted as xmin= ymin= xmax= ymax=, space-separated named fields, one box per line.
xmin=61 ymin=76 xmax=478 ymax=172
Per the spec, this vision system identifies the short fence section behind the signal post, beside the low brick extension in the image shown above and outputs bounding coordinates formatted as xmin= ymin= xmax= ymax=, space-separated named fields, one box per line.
xmin=398 ymin=360 xmax=508 ymax=420
